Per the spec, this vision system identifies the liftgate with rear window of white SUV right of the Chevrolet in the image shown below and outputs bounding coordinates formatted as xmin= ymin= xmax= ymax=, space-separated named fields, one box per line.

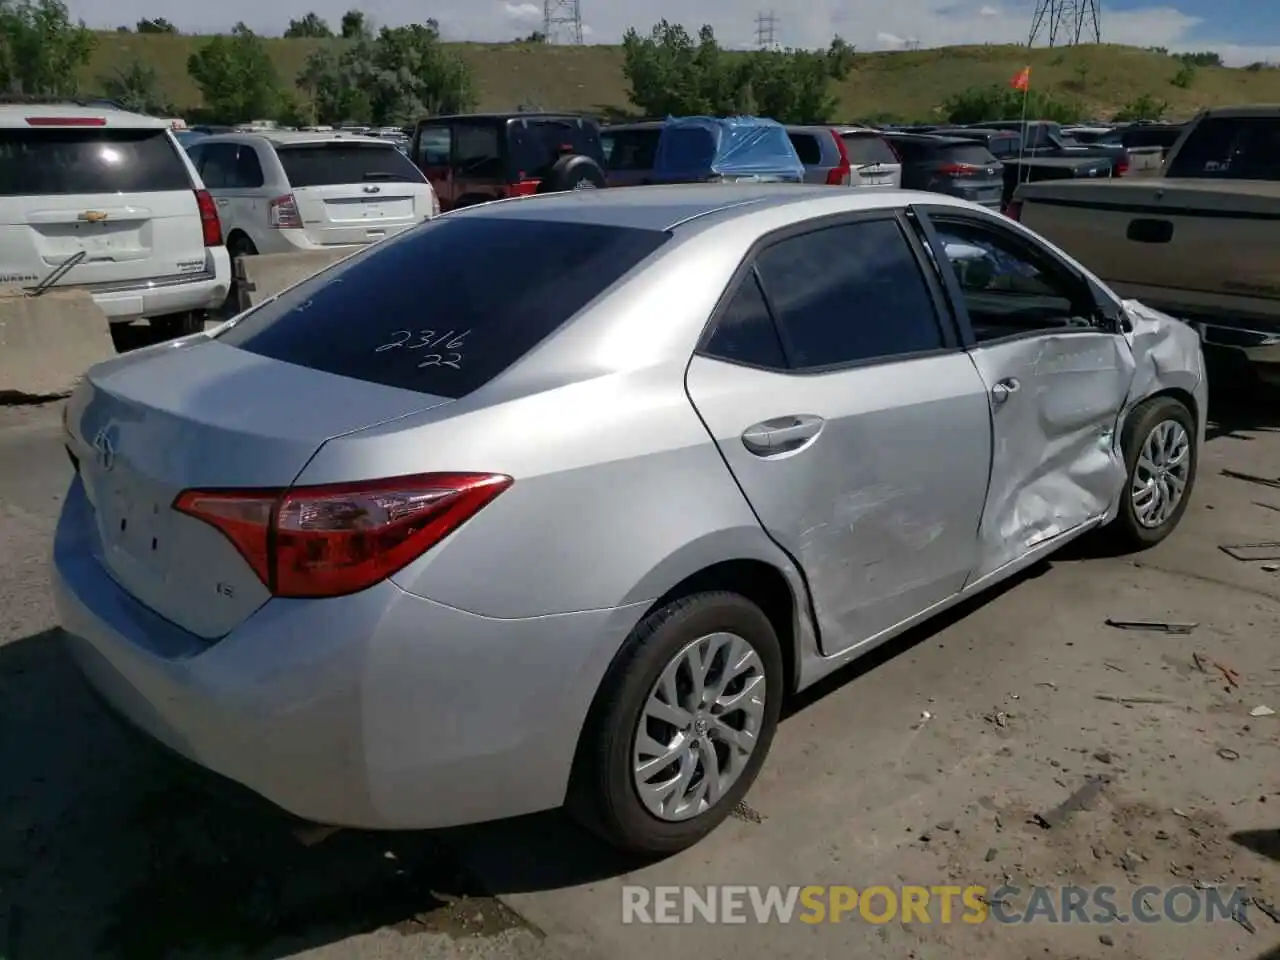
xmin=276 ymin=141 xmax=431 ymax=246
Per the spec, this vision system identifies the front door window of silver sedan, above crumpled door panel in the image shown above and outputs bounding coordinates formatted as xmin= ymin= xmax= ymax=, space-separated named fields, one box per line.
xmin=934 ymin=218 xmax=1096 ymax=342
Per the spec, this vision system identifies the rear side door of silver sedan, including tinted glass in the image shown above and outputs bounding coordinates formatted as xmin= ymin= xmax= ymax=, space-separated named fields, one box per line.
xmin=687 ymin=211 xmax=991 ymax=655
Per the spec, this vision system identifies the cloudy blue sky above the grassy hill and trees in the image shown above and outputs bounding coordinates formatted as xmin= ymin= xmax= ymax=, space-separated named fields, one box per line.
xmin=67 ymin=0 xmax=1280 ymax=65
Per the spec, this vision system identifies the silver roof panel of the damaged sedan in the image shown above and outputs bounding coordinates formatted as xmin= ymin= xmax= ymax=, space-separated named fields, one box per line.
xmin=445 ymin=183 xmax=963 ymax=230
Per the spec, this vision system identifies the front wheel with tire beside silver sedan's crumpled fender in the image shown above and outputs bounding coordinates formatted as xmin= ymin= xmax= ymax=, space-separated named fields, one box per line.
xmin=1108 ymin=397 xmax=1199 ymax=552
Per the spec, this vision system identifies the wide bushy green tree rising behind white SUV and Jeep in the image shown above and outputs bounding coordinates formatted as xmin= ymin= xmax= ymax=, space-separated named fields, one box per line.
xmin=298 ymin=20 xmax=475 ymax=125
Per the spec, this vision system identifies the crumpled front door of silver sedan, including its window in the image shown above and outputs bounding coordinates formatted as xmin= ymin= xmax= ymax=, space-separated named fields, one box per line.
xmin=918 ymin=207 xmax=1134 ymax=582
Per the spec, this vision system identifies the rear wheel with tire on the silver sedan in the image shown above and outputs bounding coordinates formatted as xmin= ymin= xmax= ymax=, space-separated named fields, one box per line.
xmin=568 ymin=591 xmax=783 ymax=856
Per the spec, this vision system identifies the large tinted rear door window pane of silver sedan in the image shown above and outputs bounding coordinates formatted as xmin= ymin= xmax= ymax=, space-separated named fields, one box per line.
xmin=756 ymin=220 xmax=943 ymax=367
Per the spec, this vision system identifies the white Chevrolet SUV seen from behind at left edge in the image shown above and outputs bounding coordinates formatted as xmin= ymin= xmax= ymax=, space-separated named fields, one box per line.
xmin=0 ymin=104 xmax=232 ymax=337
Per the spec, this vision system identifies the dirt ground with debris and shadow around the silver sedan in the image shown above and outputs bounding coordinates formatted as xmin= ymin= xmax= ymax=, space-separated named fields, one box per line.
xmin=0 ymin=366 xmax=1280 ymax=960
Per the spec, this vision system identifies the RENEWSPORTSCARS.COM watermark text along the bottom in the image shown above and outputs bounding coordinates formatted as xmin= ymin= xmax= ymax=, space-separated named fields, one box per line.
xmin=622 ymin=884 xmax=1249 ymax=924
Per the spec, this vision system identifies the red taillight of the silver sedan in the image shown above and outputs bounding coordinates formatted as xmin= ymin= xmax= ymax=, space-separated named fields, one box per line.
xmin=173 ymin=474 xmax=512 ymax=598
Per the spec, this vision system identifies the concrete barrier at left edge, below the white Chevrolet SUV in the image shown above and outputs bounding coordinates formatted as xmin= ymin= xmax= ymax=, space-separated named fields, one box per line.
xmin=0 ymin=287 xmax=115 ymax=403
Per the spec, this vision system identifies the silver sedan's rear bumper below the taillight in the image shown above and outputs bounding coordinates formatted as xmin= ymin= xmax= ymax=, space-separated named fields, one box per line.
xmin=54 ymin=480 xmax=643 ymax=829
